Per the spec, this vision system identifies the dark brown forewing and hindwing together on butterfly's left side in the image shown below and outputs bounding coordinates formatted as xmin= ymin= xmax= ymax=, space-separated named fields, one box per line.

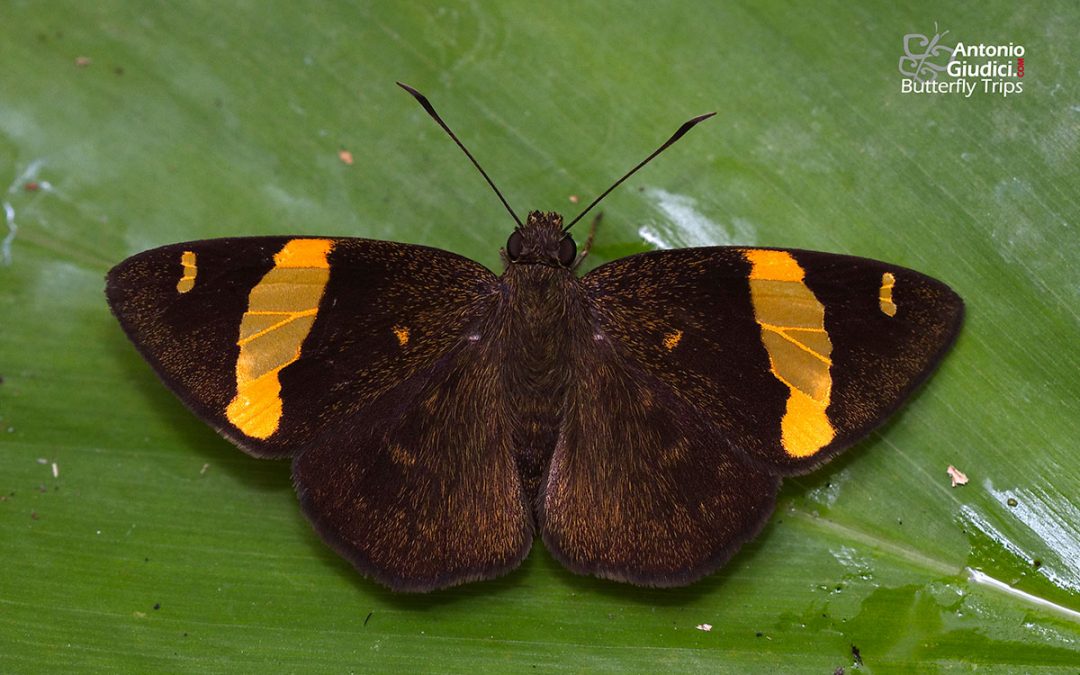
xmin=107 ymin=238 xmax=532 ymax=590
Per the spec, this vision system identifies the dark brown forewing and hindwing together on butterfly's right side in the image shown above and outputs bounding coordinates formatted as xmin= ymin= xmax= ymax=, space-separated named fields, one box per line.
xmin=539 ymin=247 xmax=963 ymax=585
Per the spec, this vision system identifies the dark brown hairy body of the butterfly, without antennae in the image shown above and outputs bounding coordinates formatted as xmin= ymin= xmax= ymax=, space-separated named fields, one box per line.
xmin=501 ymin=212 xmax=586 ymax=504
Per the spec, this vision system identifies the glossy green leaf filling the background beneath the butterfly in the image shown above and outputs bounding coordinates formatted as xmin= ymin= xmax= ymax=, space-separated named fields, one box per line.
xmin=0 ymin=0 xmax=1080 ymax=673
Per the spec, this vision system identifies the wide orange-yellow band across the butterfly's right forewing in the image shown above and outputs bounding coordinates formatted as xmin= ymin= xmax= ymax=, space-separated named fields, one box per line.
xmin=743 ymin=248 xmax=836 ymax=457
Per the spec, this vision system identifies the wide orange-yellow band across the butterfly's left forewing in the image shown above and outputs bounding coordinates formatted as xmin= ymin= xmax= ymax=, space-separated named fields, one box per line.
xmin=226 ymin=239 xmax=334 ymax=438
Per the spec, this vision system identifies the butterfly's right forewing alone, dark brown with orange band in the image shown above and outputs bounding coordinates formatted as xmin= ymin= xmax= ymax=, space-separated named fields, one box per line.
xmin=583 ymin=247 xmax=963 ymax=475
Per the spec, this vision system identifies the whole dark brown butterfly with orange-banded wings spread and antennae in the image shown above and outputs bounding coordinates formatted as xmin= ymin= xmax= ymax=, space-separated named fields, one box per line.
xmin=106 ymin=84 xmax=963 ymax=591
